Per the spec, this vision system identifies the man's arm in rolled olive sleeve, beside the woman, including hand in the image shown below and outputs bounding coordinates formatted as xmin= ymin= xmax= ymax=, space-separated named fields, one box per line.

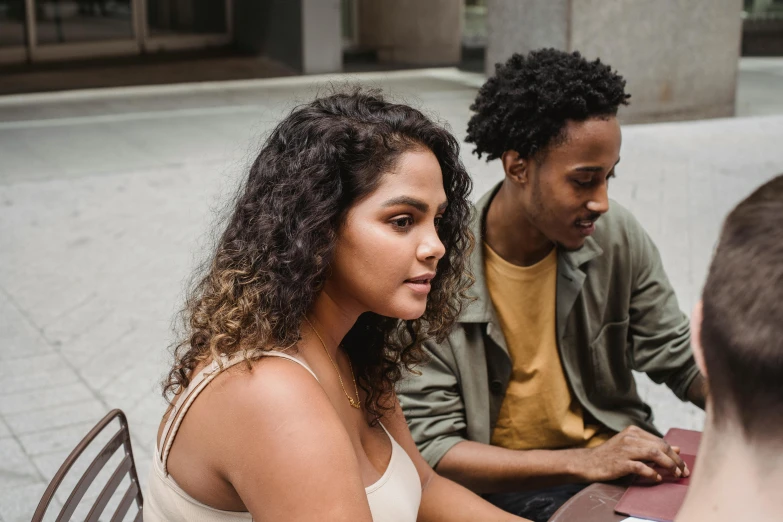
xmin=398 ymin=332 xmax=689 ymax=493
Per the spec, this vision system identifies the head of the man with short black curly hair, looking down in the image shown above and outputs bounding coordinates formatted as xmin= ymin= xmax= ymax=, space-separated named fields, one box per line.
xmin=466 ymin=49 xmax=630 ymax=250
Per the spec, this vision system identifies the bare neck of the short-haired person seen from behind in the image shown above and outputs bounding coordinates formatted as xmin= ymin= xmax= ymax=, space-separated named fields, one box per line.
xmin=676 ymin=417 xmax=783 ymax=522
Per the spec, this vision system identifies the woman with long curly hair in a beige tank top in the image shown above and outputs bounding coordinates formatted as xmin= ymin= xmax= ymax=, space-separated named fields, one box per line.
xmin=145 ymin=91 xmax=519 ymax=522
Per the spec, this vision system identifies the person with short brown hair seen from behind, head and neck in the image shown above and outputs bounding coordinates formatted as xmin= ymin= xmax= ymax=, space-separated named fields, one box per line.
xmin=677 ymin=175 xmax=783 ymax=522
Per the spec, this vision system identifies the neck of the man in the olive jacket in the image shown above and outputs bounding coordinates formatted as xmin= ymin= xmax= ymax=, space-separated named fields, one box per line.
xmin=484 ymin=180 xmax=555 ymax=266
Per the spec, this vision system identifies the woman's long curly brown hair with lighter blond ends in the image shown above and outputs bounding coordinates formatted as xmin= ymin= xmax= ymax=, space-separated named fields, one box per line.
xmin=163 ymin=89 xmax=473 ymax=420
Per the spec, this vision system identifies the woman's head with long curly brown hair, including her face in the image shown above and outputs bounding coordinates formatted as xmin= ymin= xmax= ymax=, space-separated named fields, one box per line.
xmin=164 ymin=90 xmax=472 ymax=414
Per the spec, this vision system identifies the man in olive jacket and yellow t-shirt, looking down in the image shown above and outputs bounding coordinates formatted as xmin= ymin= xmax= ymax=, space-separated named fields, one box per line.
xmin=399 ymin=49 xmax=705 ymax=521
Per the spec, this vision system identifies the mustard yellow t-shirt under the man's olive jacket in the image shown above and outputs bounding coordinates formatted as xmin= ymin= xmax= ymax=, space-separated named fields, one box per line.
xmin=484 ymin=243 xmax=611 ymax=450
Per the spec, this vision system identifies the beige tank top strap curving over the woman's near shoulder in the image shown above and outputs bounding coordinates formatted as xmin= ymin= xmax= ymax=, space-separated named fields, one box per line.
xmin=158 ymin=349 xmax=320 ymax=475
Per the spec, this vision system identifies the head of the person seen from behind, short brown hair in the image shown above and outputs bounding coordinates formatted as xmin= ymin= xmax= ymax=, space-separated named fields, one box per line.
xmin=692 ymin=175 xmax=783 ymax=447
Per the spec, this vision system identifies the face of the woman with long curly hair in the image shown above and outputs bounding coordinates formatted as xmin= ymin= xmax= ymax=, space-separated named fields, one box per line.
xmin=326 ymin=145 xmax=446 ymax=319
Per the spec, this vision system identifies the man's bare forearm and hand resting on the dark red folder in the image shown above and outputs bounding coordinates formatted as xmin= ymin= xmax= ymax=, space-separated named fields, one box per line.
xmin=435 ymin=426 xmax=690 ymax=493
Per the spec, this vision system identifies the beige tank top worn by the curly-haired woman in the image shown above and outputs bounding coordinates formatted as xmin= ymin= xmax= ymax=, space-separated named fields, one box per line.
xmin=144 ymin=350 xmax=421 ymax=522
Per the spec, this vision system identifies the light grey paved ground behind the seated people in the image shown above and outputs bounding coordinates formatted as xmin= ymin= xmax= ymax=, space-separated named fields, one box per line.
xmin=0 ymin=60 xmax=783 ymax=522
